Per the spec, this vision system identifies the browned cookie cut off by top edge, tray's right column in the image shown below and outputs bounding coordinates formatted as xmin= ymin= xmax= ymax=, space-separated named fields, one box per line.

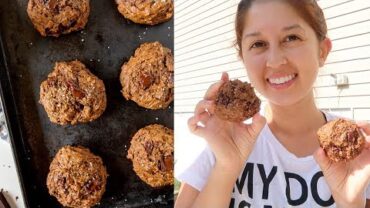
xmin=116 ymin=0 xmax=173 ymax=25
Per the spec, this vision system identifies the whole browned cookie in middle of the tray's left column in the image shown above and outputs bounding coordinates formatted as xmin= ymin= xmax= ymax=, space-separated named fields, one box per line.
xmin=40 ymin=61 xmax=107 ymax=125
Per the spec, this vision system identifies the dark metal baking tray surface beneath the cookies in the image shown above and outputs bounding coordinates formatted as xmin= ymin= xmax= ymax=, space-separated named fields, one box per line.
xmin=0 ymin=0 xmax=173 ymax=207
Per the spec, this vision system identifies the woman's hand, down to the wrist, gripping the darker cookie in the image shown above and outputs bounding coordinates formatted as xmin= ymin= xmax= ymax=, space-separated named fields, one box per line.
xmin=188 ymin=73 xmax=266 ymax=175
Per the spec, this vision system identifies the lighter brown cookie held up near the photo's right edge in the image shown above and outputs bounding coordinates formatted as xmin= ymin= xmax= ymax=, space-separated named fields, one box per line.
xmin=317 ymin=118 xmax=365 ymax=162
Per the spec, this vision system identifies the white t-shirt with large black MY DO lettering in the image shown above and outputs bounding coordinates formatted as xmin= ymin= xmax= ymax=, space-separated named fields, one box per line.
xmin=176 ymin=113 xmax=370 ymax=208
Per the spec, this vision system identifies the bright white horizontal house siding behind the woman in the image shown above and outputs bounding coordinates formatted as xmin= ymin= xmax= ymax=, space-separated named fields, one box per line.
xmin=175 ymin=0 xmax=370 ymax=193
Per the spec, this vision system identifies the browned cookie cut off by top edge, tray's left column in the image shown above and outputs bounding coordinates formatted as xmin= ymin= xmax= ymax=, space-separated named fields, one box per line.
xmin=27 ymin=0 xmax=90 ymax=37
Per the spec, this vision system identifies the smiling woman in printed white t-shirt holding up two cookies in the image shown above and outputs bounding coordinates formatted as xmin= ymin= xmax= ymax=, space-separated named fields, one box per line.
xmin=175 ymin=0 xmax=370 ymax=208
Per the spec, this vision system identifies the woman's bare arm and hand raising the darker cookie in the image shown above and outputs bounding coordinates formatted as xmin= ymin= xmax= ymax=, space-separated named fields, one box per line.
xmin=176 ymin=73 xmax=266 ymax=208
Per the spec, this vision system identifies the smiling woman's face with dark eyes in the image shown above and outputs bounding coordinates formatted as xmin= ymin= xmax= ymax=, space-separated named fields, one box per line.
xmin=242 ymin=1 xmax=326 ymax=106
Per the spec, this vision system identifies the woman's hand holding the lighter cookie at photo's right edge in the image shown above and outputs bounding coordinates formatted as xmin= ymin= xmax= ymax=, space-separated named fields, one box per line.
xmin=314 ymin=122 xmax=370 ymax=208
